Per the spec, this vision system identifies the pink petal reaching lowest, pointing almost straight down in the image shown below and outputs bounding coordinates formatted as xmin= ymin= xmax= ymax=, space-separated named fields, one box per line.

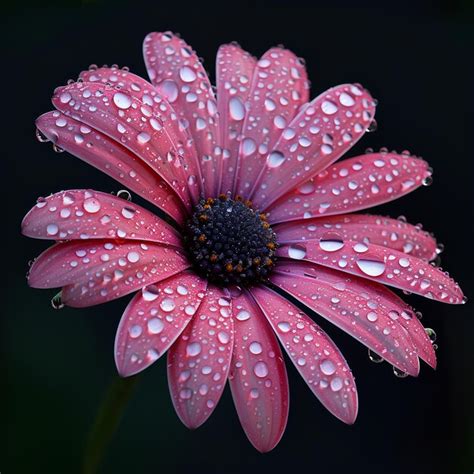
xmin=229 ymin=292 xmax=289 ymax=452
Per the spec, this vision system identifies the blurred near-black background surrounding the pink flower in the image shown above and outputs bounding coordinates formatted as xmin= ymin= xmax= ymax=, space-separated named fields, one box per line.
xmin=0 ymin=0 xmax=474 ymax=474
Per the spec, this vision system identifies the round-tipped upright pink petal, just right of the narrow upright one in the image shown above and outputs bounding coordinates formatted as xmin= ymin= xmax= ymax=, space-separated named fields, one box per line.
xmin=234 ymin=48 xmax=309 ymax=197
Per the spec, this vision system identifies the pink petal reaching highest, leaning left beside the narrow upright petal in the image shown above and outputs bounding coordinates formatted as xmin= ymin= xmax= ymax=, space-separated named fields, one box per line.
xmin=143 ymin=32 xmax=222 ymax=197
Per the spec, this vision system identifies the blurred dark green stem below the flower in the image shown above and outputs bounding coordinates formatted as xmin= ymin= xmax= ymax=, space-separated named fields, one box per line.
xmin=82 ymin=376 xmax=139 ymax=474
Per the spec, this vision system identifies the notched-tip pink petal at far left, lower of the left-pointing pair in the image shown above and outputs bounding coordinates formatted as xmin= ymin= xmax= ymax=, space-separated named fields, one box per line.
xmin=28 ymin=240 xmax=189 ymax=307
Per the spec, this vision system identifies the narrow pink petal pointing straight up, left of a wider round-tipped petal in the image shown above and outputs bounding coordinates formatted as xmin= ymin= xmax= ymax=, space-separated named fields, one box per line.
xmin=216 ymin=44 xmax=257 ymax=194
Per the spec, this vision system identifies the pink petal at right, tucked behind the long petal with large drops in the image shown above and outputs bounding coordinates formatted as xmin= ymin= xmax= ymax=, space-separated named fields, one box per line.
xmin=273 ymin=214 xmax=438 ymax=260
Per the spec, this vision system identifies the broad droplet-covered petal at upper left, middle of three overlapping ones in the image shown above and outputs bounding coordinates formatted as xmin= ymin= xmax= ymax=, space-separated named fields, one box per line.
xmin=52 ymin=82 xmax=198 ymax=206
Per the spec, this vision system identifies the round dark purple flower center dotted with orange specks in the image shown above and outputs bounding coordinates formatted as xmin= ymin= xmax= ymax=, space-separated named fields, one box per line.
xmin=184 ymin=195 xmax=277 ymax=286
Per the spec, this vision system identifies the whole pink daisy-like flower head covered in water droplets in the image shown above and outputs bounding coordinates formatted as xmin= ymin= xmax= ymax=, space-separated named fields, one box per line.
xmin=22 ymin=33 xmax=464 ymax=451
